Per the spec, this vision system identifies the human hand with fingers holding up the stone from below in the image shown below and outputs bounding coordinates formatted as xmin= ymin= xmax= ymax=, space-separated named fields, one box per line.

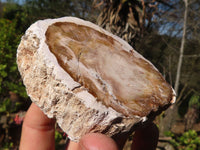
xmin=19 ymin=104 xmax=158 ymax=150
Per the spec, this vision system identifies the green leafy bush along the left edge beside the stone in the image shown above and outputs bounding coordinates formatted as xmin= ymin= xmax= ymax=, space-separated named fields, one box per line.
xmin=0 ymin=18 xmax=27 ymax=112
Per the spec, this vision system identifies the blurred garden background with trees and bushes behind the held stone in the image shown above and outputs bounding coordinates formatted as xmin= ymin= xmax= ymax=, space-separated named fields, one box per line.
xmin=0 ymin=0 xmax=200 ymax=150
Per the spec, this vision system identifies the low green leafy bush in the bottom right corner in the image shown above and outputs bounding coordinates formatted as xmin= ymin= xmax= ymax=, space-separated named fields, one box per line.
xmin=166 ymin=130 xmax=200 ymax=150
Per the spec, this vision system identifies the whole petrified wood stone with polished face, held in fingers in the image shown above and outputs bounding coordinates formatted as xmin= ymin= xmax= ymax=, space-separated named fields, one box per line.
xmin=17 ymin=17 xmax=175 ymax=141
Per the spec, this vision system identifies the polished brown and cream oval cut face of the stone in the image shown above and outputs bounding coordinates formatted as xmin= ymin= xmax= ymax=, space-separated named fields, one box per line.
xmin=46 ymin=22 xmax=173 ymax=116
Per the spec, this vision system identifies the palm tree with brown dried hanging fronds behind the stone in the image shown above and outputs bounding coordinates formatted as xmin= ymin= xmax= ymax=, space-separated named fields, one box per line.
xmin=94 ymin=0 xmax=171 ymax=46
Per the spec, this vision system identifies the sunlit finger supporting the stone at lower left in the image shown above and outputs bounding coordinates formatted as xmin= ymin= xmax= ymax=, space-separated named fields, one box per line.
xmin=19 ymin=103 xmax=55 ymax=150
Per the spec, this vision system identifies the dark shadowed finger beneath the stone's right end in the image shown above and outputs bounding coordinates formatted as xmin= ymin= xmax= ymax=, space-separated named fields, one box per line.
xmin=131 ymin=123 xmax=159 ymax=150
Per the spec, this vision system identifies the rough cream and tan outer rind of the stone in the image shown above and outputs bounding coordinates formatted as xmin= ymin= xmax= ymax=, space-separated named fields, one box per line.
xmin=17 ymin=17 xmax=145 ymax=141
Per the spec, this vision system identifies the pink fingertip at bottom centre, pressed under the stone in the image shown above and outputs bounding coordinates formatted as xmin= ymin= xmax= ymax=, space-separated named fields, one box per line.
xmin=79 ymin=133 xmax=118 ymax=150
